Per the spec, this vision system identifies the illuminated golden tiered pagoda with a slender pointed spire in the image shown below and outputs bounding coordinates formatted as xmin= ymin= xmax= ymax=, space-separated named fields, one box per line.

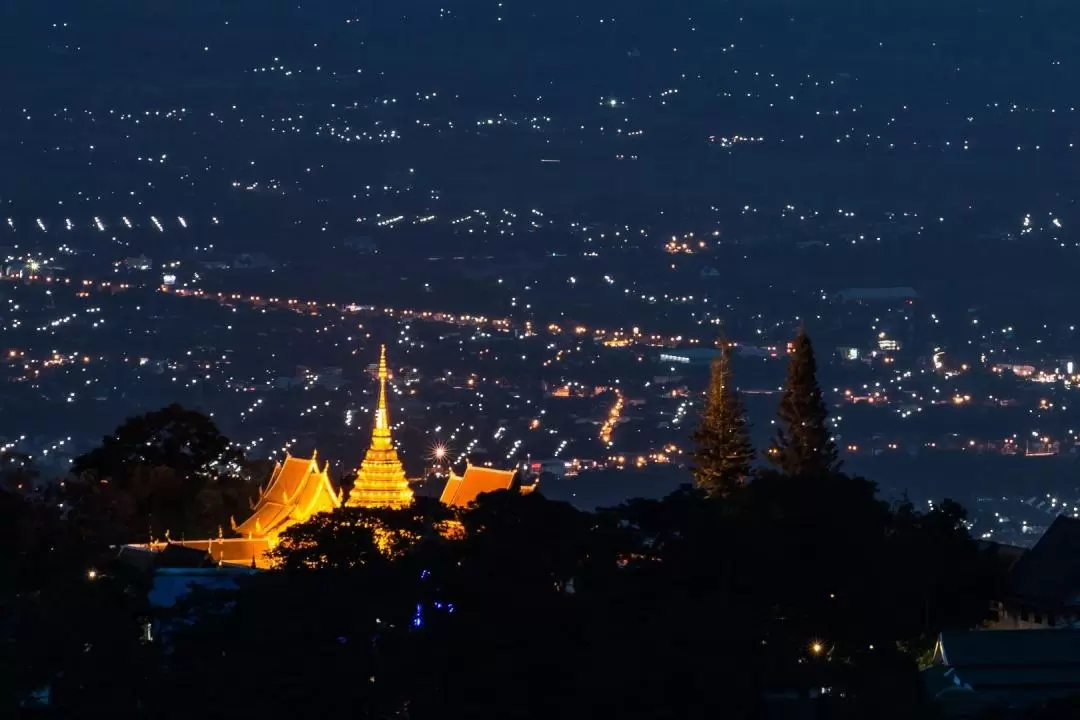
xmin=346 ymin=345 xmax=413 ymax=507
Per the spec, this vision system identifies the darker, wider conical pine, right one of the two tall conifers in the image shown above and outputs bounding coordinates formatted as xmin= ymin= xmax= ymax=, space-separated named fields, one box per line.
xmin=768 ymin=328 xmax=840 ymax=476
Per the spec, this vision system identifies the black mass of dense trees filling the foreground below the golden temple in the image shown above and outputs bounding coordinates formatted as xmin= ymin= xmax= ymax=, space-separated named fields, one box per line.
xmin=0 ymin=369 xmax=1028 ymax=720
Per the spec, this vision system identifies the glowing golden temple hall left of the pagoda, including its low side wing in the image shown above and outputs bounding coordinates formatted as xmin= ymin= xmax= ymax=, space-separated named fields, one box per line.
xmin=127 ymin=453 xmax=341 ymax=568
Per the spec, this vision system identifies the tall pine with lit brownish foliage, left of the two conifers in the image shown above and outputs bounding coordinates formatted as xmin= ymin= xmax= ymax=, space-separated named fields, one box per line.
xmin=693 ymin=338 xmax=754 ymax=497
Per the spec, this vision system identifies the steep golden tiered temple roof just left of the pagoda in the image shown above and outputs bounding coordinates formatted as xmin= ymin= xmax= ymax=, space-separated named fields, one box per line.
xmin=233 ymin=456 xmax=341 ymax=539
